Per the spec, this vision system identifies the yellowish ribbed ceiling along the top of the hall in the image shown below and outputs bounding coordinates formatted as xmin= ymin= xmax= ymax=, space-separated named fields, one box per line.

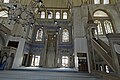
xmin=0 ymin=0 xmax=120 ymax=9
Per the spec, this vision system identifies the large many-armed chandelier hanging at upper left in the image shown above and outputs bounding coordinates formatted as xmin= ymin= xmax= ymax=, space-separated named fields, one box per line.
xmin=0 ymin=0 xmax=46 ymax=35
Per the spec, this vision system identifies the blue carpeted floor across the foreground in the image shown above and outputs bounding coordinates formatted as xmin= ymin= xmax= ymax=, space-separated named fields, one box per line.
xmin=0 ymin=68 xmax=104 ymax=80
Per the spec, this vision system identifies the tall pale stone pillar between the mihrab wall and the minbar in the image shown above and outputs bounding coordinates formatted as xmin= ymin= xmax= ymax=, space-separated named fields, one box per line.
xmin=73 ymin=6 xmax=90 ymax=72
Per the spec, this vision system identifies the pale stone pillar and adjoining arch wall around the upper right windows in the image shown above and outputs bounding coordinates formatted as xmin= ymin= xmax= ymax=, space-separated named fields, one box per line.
xmin=73 ymin=4 xmax=120 ymax=72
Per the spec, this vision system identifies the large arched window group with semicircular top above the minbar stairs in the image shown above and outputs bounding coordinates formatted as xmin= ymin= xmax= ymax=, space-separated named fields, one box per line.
xmin=93 ymin=10 xmax=114 ymax=35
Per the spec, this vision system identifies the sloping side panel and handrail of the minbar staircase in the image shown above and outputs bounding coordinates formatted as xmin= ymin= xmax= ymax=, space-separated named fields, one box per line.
xmin=91 ymin=39 xmax=115 ymax=71
